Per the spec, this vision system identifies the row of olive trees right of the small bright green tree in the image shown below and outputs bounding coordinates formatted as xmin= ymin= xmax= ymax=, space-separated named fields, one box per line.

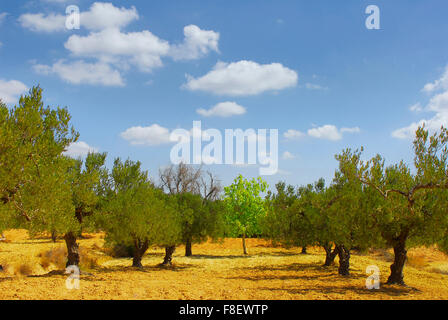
xmin=262 ymin=127 xmax=448 ymax=284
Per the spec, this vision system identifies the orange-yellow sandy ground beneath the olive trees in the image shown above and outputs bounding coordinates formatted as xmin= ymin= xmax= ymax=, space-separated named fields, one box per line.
xmin=0 ymin=230 xmax=448 ymax=300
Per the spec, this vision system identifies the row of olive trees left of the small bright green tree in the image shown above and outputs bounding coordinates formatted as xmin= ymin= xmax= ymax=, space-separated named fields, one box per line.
xmin=0 ymin=87 xmax=229 ymax=267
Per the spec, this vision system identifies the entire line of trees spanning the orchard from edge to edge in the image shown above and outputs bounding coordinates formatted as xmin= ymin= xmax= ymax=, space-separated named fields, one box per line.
xmin=0 ymin=87 xmax=448 ymax=284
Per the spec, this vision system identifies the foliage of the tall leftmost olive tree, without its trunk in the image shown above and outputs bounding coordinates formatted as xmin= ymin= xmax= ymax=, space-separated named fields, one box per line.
xmin=0 ymin=87 xmax=78 ymax=230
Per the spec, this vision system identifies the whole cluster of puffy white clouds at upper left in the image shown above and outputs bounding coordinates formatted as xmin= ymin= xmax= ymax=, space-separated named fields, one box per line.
xmin=24 ymin=2 xmax=219 ymax=85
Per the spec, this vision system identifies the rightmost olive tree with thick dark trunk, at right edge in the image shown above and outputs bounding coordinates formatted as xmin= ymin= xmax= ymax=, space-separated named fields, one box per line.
xmin=337 ymin=127 xmax=448 ymax=285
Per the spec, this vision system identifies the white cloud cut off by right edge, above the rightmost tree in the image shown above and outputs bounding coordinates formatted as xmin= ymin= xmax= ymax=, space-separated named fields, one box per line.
xmin=392 ymin=67 xmax=448 ymax=139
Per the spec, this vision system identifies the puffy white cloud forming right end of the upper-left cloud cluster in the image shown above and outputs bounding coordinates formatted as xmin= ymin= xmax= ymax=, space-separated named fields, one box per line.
xmin=170 ymin=25 xmax=219 ymax=60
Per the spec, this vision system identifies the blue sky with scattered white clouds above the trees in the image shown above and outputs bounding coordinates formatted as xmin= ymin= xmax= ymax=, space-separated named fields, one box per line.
xmin=0 ymin=0 xmax=448 ymax=189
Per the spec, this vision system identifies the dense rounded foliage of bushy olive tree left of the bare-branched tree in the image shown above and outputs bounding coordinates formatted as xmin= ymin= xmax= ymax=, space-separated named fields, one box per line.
xmin=97 ymin=159 xmax=181 ymax=251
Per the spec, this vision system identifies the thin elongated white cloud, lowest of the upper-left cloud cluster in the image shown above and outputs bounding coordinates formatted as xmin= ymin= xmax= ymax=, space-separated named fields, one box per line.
xmin=33 ymin=60 xmax=124 ymax=86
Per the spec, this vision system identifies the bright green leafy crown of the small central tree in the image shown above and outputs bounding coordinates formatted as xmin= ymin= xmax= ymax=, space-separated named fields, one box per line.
xmin=224 ymin=175 xmax=268 ymax=237
